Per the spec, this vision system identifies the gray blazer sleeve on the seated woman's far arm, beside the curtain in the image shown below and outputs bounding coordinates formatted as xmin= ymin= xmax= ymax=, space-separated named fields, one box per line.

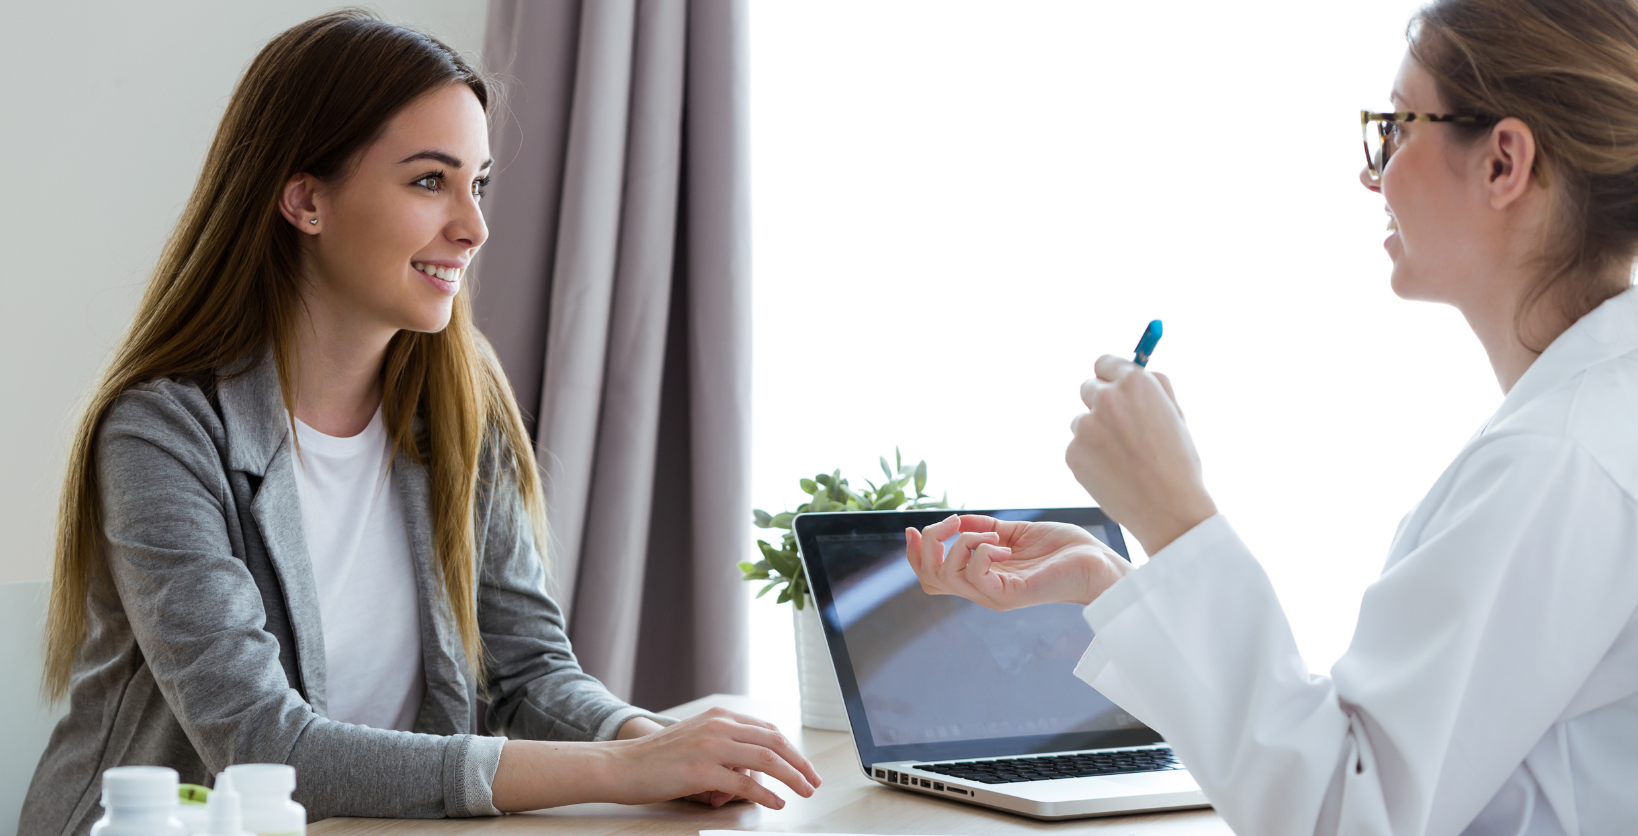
xmin=477 ymin=438 xmax=675 ymax=741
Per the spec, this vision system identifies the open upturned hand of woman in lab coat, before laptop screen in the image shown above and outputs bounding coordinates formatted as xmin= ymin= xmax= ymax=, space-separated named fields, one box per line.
xmin=904 ymin=515 xmax=1132 ymax=610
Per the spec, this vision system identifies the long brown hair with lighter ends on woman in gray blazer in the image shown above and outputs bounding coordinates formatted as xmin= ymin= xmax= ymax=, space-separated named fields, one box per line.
xmin=44 ymin=10 xmax=545 ymax=700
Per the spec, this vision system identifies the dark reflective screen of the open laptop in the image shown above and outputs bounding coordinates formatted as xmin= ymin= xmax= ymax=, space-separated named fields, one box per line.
xmin=796 ymin=508 xmax=1158 ymax=764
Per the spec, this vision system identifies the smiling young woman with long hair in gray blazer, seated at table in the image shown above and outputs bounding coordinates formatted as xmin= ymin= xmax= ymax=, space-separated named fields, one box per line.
xmin=21 ymin=11 xmax=819 ymax=834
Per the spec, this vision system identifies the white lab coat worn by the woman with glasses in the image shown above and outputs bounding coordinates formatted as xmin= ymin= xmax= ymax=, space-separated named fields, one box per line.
xmin=1076 ymin=283 xmax=1638 ymax=836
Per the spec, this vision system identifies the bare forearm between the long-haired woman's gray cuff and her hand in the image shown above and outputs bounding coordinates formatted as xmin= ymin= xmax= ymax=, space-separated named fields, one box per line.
xmin=491 ymin=741 xmax=618 ymax=813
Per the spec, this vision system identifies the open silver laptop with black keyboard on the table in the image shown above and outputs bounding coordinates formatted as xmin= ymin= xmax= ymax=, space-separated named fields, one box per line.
xmin=793 ymin=508 xmax=1209 ymax=820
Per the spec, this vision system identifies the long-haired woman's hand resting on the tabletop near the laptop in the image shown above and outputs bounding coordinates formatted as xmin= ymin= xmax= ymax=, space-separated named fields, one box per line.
xmin=609 ymin=708 xmax=819 ymax=810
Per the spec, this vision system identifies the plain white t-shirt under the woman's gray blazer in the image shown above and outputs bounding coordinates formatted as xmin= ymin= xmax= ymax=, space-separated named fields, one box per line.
xmin=295 ymin=410 xmax=426 ymax=731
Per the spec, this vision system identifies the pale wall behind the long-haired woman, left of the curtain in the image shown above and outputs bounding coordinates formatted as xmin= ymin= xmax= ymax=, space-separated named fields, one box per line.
xmin=0 ymin=0 xmax=488 ymax=582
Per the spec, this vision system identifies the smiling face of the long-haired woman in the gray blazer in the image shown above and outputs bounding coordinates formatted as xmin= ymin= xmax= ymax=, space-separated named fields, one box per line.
xmin=287 ymin=84 xmax=493 ymax=333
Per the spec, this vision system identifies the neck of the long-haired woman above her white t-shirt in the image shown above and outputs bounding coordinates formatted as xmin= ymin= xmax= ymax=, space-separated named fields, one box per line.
xmin=295 ymin=283 xmax=395 ymax=438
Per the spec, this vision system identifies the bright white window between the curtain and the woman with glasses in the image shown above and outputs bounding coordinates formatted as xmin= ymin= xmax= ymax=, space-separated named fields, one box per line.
xmin=747 ymin=0 xmax=1500 ymax=698
